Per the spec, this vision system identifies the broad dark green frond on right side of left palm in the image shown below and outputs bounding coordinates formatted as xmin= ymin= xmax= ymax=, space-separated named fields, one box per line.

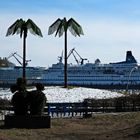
xmin=26 ymin=19 xmax=43 ymax=37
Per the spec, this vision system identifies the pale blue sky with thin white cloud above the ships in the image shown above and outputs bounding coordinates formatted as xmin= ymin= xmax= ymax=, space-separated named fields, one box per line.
xmin=0 ymin=0 xmax=140 ymax=67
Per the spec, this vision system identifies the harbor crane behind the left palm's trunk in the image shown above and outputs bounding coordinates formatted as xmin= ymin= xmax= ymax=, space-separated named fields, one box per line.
xmin=7 ymin=52 xmax=31 ymax=66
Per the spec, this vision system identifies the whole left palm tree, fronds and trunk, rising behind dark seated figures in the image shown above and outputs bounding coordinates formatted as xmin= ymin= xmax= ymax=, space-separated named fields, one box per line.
xmin=6 ymin=19 xmax=43 ymax=79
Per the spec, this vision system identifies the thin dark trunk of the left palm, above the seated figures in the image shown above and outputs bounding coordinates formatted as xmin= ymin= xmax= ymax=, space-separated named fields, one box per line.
xmin=22 ymin=32 xmax=26 ymax=79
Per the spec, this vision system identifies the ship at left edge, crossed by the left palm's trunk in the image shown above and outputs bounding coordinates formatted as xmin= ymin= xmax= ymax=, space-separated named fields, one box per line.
xmin=0 ymin=57 xmax=45 ymax=87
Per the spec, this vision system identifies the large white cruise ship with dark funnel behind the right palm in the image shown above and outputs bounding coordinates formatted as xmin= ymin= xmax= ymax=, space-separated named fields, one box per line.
xmin=40 ymin=51 xmax=140 ymax=89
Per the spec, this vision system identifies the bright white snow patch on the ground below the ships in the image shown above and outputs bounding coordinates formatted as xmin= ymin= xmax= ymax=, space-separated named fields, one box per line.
xmin=0 ymin=86 xmax=122 ymax=102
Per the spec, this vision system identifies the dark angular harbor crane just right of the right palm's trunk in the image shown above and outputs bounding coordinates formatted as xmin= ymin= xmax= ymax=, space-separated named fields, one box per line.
xmin=67 ymin=48 xmax=87 ymax=65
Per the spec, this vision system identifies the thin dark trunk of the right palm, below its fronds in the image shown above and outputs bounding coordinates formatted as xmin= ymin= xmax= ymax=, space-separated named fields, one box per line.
xmin=64 ymin=30 xmax=68 ymax=88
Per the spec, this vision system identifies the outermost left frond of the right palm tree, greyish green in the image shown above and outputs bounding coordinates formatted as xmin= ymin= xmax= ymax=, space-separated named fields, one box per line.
xmin=48 ymin=18 xmax=62 ymax=35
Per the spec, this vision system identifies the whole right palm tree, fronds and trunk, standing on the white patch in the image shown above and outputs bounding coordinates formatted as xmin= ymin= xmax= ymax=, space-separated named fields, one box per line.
xmin=48 ymin=17 xmax=84 ymax=88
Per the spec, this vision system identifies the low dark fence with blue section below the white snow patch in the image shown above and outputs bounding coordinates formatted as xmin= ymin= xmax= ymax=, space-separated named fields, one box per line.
xmin=0 ymin=95 xmax=140 ymax=118
